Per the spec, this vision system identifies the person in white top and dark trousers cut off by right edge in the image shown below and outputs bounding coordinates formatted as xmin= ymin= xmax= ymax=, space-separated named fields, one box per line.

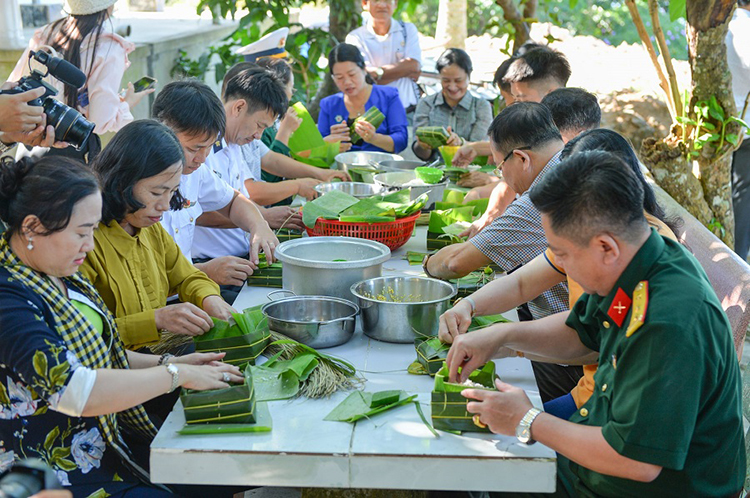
xmin=726 ymin=0 xmax=750 ymax=259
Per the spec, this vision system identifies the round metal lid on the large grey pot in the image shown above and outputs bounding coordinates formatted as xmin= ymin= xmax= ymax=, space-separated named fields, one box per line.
xmin=274 ymin=237 xmax=391 ymax=270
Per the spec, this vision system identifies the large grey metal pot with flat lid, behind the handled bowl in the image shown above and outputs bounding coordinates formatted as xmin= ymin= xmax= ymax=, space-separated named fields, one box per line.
xmin=275 ymin=237 xmax=391 ymax=300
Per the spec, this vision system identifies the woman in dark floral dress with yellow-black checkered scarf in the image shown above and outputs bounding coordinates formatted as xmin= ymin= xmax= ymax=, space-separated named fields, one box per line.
xmin=0 ymin=157 xmax=242 ymax=497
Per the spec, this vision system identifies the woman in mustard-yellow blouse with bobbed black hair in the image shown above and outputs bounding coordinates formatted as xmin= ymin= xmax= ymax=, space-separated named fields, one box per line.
xmin=81 ymin=120 xmax=234 ymax=349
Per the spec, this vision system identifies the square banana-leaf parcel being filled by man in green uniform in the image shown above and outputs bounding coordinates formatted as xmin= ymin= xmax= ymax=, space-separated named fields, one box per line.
xmin=430 ymin=362 xmax=496 ymax=433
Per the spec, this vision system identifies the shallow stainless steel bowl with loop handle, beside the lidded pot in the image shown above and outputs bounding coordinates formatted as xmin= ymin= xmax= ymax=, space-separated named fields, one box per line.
xmin=261 ymin=296 xmax=359 ymax=349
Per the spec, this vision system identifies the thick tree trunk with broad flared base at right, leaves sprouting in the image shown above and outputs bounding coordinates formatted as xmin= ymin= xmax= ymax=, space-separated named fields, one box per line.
xmin=641 ymin=0 xmax=739 ymax=247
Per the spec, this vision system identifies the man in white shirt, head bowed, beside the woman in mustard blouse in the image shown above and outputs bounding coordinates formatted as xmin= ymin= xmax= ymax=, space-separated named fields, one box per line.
xmin=153 ymin=81 xmax=279 ymax=285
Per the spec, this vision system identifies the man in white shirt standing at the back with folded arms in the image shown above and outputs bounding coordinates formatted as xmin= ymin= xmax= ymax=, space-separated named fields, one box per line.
xmin=346 ymin=0 xmax=422 ymax=112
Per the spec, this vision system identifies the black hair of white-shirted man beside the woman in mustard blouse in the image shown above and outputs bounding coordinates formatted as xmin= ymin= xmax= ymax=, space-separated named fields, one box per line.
xmin=151 ymin=80 xmax=227 ymax=136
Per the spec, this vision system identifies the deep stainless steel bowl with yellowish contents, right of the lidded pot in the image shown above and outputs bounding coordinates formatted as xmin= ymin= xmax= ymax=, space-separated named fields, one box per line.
xmin=351 ymin=277 xmax=457 ymax=343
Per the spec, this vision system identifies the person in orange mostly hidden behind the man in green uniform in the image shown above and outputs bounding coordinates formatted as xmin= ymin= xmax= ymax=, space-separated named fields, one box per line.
xmin=439 ymin=128 xmax=676 ymax=419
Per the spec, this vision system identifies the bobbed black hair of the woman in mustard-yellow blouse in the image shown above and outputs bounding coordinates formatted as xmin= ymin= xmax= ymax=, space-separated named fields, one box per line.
xmin=91 ymin=119 xmax=185 ymax=224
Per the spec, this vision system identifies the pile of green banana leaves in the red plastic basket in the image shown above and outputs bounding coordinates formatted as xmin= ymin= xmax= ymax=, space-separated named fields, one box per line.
xmin=302 ymin=189 xmax=427 ymax=228
